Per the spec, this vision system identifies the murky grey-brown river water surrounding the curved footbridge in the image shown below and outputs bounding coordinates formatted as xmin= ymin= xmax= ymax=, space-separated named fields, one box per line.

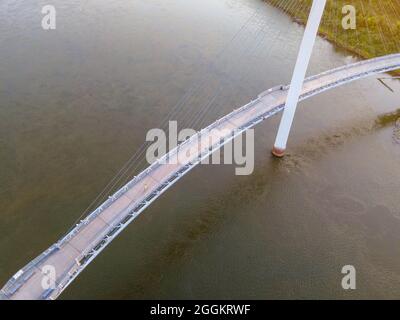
xmin=0 ymin=0 xmax=400 ymax=299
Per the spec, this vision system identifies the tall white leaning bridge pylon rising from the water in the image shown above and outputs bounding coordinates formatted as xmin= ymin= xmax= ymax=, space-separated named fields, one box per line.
xmin=272 ymin=0 xmax=326 ymax=157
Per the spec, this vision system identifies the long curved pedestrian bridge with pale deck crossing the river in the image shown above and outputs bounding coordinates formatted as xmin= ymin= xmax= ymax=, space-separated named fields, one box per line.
xmin=0 ymin=54 xmax=400 ymax=299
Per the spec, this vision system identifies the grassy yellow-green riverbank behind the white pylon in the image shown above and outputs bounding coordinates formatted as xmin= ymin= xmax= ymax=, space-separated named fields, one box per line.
xmin=266 ymin=0 xmax=400 ymax=74
